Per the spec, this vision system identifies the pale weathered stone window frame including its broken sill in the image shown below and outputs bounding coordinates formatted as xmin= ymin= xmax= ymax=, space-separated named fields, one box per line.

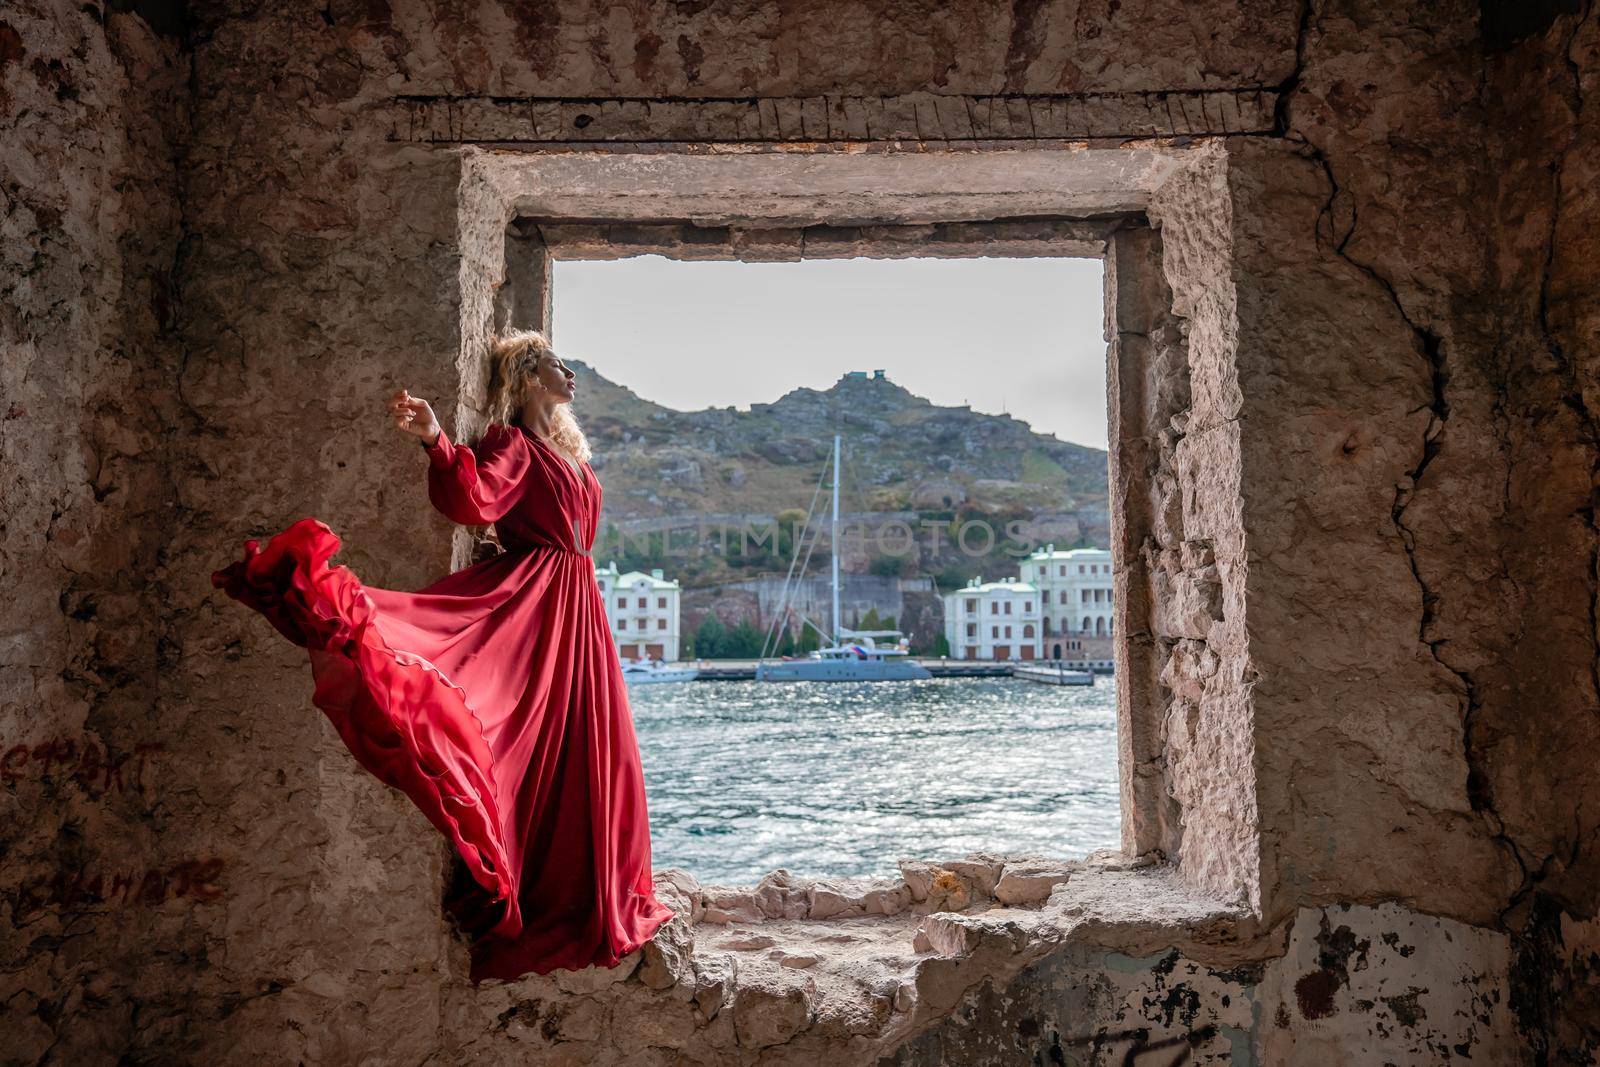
xmin=441 ymin=141 xmax=1259 ymax=1043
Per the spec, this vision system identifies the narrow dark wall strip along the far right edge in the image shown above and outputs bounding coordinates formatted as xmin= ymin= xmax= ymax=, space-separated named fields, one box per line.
xmin=1470 ymin=3 xmax=1600 ymax=1062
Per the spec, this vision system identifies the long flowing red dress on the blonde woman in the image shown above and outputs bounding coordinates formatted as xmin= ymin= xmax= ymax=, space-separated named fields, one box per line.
xmin=211 ymin=424 xmax=674 ymax=982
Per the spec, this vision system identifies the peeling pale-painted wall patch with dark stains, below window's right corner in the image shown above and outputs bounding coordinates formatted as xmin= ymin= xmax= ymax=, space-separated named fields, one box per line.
xmin=880 ymin=904 xmax=1520 ymax=1067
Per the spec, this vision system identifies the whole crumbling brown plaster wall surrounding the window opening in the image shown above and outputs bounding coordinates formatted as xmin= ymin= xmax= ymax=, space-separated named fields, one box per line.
xmin=0 ymin=0 xmax=1600 ymax=1062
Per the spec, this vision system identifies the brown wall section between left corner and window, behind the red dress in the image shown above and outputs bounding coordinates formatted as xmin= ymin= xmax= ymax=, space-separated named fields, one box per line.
xmin=164 ymin=5 xmax=486 ymax=1062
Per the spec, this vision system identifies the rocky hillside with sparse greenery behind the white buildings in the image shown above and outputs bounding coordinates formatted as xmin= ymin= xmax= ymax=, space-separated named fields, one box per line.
xmin=571 ymin=360 xmax=1107 ymax=525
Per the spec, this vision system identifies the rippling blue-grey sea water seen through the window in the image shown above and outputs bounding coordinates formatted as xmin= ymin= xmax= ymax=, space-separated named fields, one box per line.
xmin=629 ymin=677 xmax=1120 ymax=885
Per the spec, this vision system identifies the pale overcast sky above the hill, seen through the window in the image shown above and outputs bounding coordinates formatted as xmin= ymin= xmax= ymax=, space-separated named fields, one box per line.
xmin=552 ymin=256 xmax=1106 ymax=448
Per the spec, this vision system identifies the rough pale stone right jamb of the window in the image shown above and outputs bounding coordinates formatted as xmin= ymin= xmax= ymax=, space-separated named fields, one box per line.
xmin=1139 ymin=146 xmax=1262 ymax=910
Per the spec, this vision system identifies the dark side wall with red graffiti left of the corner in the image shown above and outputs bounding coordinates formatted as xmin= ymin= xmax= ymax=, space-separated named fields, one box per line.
xmin=0 ymin=0 xmax=190 ymax=1061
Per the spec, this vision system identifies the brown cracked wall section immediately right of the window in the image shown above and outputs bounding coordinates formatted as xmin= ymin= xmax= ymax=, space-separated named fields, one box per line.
xmin=1229 ymin=3 xmax=1517 ymax=921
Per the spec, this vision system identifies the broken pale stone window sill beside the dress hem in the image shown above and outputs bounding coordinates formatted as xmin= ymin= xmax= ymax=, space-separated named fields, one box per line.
xmin=489 ymin=851 xmax=1250 ymax=1049
